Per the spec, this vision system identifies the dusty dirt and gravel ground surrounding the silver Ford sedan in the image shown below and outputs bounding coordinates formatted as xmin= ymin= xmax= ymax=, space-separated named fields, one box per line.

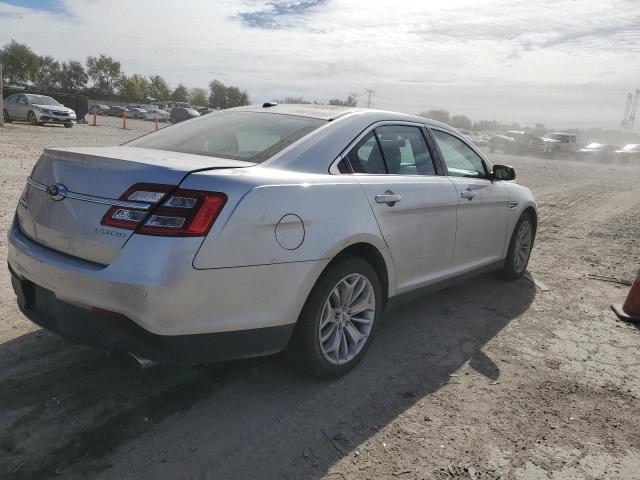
xmin=0 ymin=118 xmax=640 ymax=480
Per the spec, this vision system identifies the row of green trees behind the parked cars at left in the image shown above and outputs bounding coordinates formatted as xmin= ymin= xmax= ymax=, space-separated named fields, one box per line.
xmin=0 ymin=40 xmax=250 ymax=108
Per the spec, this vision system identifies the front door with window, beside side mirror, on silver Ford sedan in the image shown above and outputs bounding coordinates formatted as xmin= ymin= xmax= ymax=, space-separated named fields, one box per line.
xmin=431 ymin=127 xmax=509 ymax=273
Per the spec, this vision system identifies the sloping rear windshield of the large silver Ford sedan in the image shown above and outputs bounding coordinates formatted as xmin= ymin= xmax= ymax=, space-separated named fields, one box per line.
xmin=127 ymin=112 xmax=327 ymax=163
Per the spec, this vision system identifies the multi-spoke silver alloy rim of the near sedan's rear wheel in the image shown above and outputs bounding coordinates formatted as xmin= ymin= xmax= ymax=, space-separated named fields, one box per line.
xmin=319 ymin=273 xmax=376 ymax=365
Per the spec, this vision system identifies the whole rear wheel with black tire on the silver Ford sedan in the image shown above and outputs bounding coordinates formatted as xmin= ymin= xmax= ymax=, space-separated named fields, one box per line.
xmin=285 ymin=256 xmax=383 ymax=378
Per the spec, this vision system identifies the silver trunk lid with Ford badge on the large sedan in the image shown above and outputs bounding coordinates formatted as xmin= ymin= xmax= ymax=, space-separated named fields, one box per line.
xmin=17 ymin=147 xmax=254 ymax=265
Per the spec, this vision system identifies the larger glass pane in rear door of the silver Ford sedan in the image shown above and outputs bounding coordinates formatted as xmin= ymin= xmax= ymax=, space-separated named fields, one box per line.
xmin=375 ymin=125 xmax=436 ymax=175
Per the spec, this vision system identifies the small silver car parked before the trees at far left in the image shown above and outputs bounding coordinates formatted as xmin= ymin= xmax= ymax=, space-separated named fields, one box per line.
xmin=2 ymin=93 xmax=76 ymax=128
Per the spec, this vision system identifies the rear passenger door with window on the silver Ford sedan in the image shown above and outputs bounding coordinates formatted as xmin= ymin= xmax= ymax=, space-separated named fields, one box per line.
xmin=346 ymin=123 xmax=458 ymax=293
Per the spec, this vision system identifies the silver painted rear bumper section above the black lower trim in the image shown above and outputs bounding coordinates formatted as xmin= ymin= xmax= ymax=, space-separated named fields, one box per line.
xmin=8 ymin=216 xmax=329 ymax=336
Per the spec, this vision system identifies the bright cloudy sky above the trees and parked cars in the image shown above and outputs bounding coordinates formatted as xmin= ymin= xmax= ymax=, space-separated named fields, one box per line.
xmin=0 ymin=0 xmax=640 ymax=131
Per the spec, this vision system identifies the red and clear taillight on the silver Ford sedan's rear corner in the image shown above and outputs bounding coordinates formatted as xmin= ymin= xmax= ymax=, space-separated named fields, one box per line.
xmin=101 ymin=183 xmax=227 ymax=237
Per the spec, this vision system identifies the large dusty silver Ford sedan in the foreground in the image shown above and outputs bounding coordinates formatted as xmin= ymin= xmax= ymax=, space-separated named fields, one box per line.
xmin=9 ymin=103 xmax=537 ymax=376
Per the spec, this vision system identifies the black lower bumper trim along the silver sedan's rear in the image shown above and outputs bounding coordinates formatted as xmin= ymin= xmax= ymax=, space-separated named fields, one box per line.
xmin=11 ymin=271 xmax=294 ymax=364
